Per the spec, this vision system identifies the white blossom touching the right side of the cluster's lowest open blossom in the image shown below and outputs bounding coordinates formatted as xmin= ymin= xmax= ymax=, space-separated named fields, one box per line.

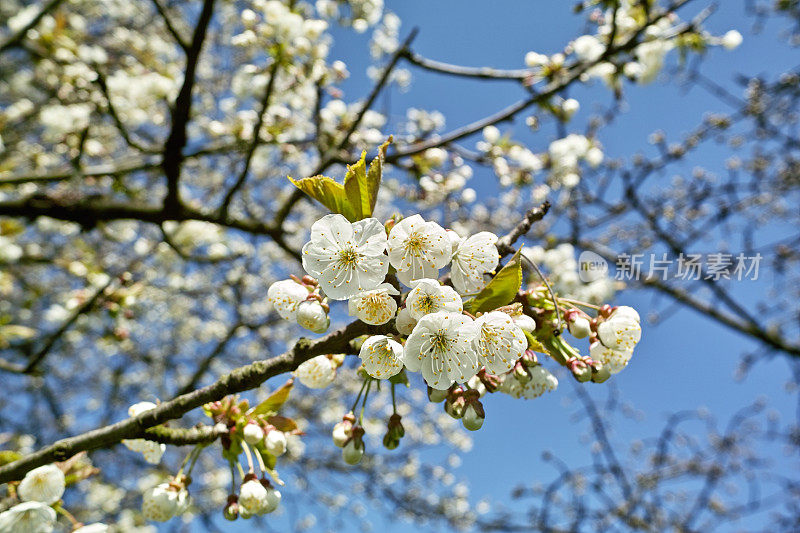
xmin=472 ymin=311 xmax=528 ymax=374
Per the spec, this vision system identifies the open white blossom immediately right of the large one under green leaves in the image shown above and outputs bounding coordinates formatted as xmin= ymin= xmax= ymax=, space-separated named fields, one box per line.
xmin=388 ymin=215 xmax=452 ymax=287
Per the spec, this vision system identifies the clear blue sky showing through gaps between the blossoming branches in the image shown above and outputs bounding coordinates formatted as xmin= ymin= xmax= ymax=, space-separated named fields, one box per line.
xmin=202 ymin=0 xmax=797 ymax=532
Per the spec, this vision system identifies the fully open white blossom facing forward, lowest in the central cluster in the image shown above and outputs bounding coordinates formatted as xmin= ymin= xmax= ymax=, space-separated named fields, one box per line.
xmin=403 ymin=311 xmax=478 ymax=390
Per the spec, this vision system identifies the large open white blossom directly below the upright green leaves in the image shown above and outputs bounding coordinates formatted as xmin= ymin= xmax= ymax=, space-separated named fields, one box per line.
xmin=302 ymin=214 xmax=389 ymax=300
